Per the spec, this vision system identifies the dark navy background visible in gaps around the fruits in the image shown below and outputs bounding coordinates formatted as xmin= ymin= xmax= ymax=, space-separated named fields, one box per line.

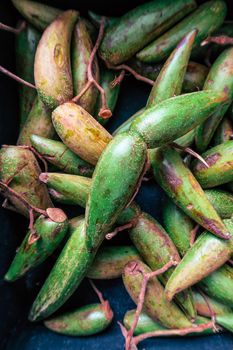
xmin=0 ymin=0 xmax=233 ymax=350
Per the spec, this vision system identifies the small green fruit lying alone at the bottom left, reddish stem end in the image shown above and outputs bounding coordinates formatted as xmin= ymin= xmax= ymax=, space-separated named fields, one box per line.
xmin=44 ymin=304 xmax=113 ymax=337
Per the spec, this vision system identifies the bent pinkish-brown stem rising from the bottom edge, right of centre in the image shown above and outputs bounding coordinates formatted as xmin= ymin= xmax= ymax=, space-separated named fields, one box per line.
xmin=125 ymin=259 xmax=177 ymax=350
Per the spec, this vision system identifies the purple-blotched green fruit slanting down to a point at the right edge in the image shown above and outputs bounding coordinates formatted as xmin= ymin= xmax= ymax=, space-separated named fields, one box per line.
xmin=150 ymin=146 xmax=229 ymax=238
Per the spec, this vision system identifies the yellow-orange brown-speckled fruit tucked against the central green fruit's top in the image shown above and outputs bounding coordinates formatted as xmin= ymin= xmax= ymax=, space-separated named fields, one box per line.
xmin=52 ymin=102 xmax=112 ymax=165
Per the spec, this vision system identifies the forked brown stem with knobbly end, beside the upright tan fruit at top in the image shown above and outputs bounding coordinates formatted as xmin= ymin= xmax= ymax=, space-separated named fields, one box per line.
xmin=72 ymin=17 xmax=112 ymax=119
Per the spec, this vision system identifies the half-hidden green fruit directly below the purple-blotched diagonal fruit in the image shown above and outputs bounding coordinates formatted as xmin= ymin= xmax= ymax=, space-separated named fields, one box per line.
xmin=162 ymin=199 xmax=195 ymax=256
